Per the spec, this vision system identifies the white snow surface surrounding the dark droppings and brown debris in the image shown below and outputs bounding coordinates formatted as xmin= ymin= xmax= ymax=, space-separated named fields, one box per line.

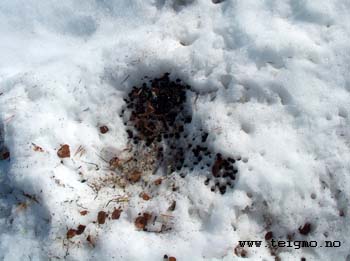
xmin=0 ymin=0 xmax=350 ymax=261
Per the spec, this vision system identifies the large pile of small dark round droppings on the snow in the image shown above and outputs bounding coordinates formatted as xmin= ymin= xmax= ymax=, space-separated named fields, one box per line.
xmin=120 ymin=73 xmax=239 ymax=194
